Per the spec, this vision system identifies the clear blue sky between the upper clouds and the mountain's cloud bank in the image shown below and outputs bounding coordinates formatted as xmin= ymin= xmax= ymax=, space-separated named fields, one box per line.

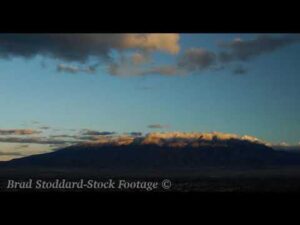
xmin=0 ymin=34 xmax=300 ymax=160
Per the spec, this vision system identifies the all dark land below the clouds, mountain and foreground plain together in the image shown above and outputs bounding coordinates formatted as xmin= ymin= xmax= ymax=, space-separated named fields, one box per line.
xmin=0 ymin=140 xmax=300 ymax=192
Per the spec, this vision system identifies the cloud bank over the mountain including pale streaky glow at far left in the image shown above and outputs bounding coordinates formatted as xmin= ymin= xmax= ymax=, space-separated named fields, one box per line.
xmin=0 ymin=124 xmax=300 ymax=161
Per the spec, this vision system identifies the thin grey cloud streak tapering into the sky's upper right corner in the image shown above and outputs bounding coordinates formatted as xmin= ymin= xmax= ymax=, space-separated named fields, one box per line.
xmin=219 ymin=34 xmax=300 ymax=63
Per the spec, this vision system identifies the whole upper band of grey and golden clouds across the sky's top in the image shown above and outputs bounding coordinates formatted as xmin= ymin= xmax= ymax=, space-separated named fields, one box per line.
xmin=0 ymin=33 xmax=300 ymax=77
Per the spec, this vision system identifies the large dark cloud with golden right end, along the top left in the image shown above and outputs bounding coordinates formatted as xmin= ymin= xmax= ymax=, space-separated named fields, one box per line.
xmin=0 ymin=34 xmax=180 ymax=62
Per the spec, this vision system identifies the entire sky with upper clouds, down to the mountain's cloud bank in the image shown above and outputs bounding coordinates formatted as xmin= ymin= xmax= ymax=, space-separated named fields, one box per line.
xmin=0 ymin=34 xmax=300 ymax=160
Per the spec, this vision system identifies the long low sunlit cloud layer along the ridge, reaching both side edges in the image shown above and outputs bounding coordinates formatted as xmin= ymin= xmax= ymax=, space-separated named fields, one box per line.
xmin=0 ymin=131 xmax=300 ymax=155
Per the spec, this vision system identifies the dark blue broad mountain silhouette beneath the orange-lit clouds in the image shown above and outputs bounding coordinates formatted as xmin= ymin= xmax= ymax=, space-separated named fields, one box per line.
xmin=0 ymin=139 xmax=300 ymax=170
